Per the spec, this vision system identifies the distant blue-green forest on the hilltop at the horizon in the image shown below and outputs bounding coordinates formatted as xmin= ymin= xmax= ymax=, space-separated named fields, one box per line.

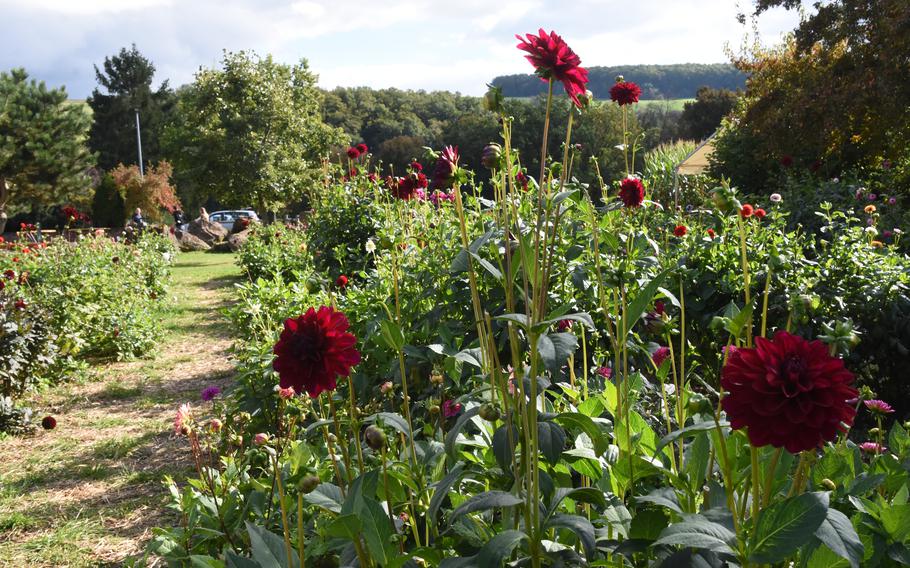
xmin=493 ymin=63 xmax=746 ymax=99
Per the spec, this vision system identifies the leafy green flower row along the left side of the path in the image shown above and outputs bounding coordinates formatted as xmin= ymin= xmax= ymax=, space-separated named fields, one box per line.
xmin=0 ymin=228 xmax=176 ymax=433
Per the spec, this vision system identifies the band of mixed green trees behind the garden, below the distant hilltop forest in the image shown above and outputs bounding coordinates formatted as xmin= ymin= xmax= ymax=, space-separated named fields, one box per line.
xmin=0 ymin=45 xmax=735 ymax=230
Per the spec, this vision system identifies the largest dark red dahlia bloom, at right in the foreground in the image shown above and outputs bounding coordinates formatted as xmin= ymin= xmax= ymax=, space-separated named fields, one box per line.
xmin=721 ymin=331 xmax=858 ymax=454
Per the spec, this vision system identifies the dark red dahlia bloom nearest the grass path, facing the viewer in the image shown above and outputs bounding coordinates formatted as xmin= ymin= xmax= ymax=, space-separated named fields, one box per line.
xmin=272 ymin=306 xmax=360 ymax=398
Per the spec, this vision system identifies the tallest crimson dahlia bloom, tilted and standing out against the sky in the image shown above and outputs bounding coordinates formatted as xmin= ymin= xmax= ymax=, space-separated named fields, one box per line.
xmin=515 ymin=28 xmax=588 ymax=106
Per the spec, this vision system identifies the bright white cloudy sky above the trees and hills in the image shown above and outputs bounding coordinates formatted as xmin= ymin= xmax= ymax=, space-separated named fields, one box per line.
xmin=0 ymin=0 xmax=798 ymax=98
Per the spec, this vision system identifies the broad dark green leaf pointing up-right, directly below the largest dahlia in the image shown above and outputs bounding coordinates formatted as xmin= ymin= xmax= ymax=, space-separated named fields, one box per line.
xmin=749 ymin=492 xmax=828 ymax=564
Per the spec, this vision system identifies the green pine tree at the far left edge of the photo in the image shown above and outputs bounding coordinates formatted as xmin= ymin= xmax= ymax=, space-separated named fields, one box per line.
xmin=0 ymin=69 xmax=94 ymax=230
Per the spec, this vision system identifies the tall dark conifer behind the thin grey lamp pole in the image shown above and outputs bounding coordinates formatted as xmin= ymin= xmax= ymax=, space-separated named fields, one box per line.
xmin=88 ymin=44 xmax=175 ymax=170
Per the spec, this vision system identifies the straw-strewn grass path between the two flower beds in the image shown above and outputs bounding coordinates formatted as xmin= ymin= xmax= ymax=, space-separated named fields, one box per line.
xmin=0 ymin=253 xmax=239 ymax=567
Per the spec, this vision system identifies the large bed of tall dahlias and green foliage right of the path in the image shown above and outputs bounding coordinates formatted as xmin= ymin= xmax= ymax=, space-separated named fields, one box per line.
xmin=152 ymin=30 xmax=910 ymax=568
